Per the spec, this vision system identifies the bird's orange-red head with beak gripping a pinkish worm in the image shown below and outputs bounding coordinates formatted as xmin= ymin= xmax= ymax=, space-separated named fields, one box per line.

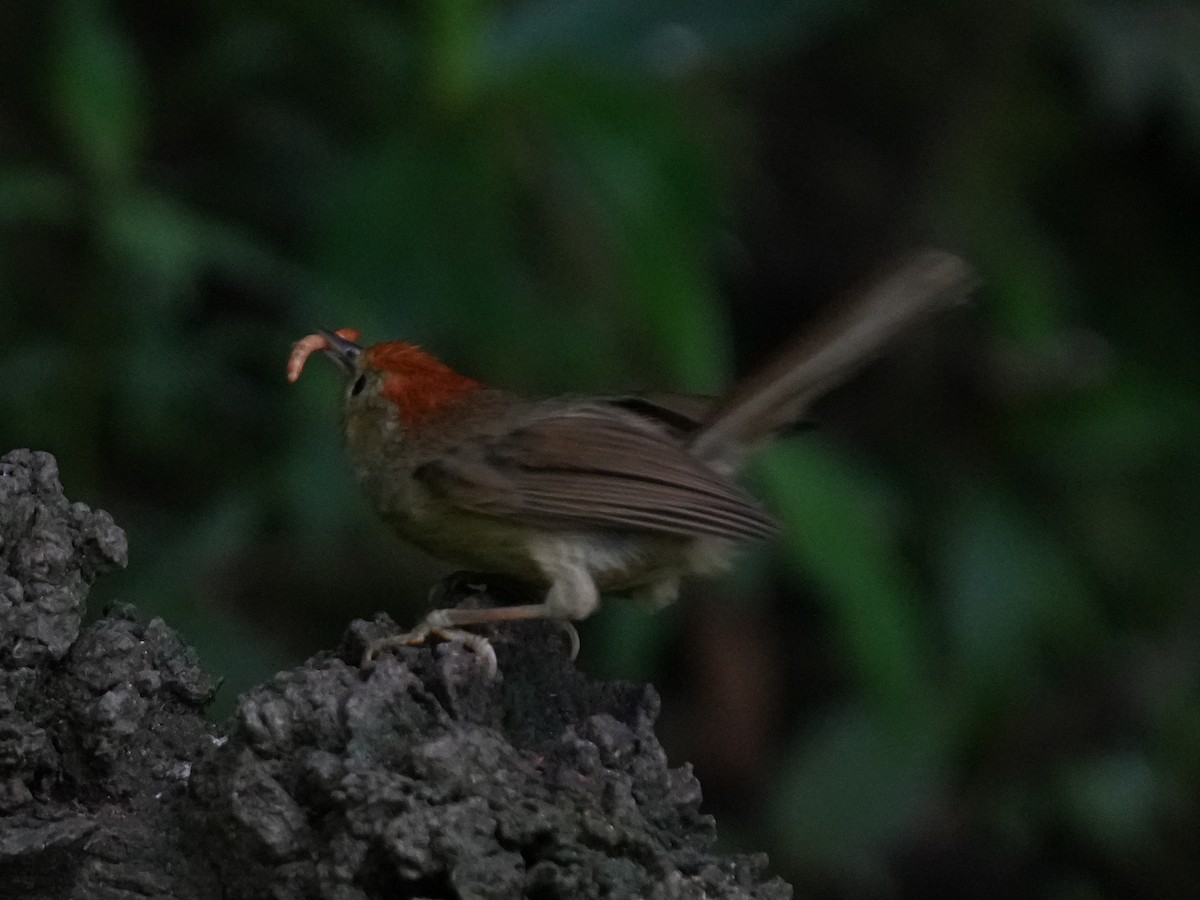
xmin=288 ymin=328 xmax=482 ymax=428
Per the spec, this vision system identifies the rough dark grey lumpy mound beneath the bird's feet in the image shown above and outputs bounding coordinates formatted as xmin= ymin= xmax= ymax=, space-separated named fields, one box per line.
xmin=0 ymin=450 xmax=792 ymax=900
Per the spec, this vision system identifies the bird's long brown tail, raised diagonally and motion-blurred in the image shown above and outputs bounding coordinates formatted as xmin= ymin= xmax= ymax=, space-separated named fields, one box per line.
xmin=691 ymin=250 xmax=976 ymax=460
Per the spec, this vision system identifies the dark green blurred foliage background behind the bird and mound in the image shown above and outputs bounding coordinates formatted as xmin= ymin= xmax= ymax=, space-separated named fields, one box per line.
xmin=0 ymin=0 xmax=1200 ymax=899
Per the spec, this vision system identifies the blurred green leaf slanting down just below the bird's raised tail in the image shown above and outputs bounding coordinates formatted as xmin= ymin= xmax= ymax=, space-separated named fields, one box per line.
xmin=755 ymin=438 xmax=930 ymax=721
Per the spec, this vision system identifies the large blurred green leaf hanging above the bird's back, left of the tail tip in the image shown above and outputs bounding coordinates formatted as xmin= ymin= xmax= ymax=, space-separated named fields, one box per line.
xmin=524 ymin=72 xmax=728 ymax=390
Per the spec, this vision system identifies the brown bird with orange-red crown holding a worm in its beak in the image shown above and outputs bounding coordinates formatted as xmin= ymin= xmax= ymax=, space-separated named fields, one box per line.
xmin=288 ymin=251 xmax=974 ymax=670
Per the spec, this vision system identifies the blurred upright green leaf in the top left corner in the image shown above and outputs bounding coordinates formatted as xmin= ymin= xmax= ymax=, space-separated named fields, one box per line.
xmin=50 ymin=0 xmax=148 ymax=185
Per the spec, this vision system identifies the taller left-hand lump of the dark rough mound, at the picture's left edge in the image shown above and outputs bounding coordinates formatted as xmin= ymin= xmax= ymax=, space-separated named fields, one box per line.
xmin=0 ymin=450 xmax=220 ymax=900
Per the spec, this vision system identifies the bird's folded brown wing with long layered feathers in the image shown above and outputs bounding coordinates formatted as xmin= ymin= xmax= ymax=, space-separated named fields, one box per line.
xmin=416 ymin=404 xmax=776 ymax=539
